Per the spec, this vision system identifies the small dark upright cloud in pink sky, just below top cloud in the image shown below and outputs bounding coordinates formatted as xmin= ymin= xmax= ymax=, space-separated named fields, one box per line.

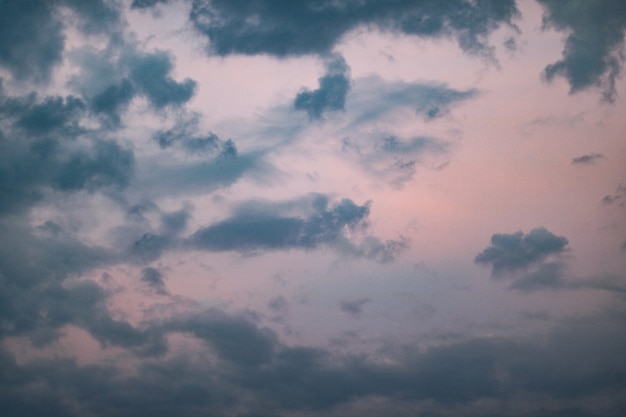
xmin=293 ymin=55 xmax=350 ymax=120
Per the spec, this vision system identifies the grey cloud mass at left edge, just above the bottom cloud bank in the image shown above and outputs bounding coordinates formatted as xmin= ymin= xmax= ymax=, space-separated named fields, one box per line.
xmin=0 ymin=222 xmax=163 ymax=353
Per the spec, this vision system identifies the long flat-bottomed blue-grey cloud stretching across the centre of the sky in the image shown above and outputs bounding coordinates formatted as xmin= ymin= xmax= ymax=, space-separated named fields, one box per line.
xmin=188 ymin=194 xmax=408 ymax=262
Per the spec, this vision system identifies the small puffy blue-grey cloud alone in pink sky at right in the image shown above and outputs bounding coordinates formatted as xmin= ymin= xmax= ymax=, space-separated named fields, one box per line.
xmin=474 ymin=227 xmax=568 ymax=276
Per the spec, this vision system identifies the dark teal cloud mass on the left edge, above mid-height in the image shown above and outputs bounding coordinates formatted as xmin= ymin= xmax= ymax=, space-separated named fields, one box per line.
xmin=0 ymin=90 xmax=135 ymax=212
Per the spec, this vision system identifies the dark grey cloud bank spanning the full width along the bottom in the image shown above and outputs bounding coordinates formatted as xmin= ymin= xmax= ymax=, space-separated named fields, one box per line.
xmin=0 ymin=302 xmax=626 ymax=417
